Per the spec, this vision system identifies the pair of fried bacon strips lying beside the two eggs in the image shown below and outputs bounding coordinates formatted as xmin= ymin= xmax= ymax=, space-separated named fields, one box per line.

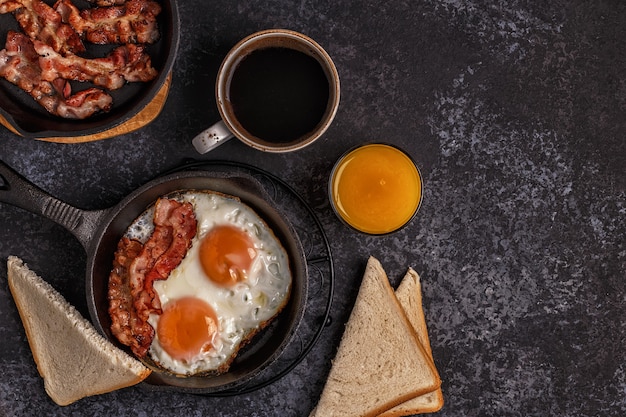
xmin=109 ymin=199 xmax=197 ymax=358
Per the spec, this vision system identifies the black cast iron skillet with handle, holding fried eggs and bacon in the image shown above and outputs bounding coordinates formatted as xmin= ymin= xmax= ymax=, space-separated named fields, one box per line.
xmin=0 ymin=161 xmax=308 ymax=393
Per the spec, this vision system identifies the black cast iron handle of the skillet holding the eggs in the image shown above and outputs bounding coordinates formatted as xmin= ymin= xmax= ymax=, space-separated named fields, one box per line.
xmin=0 ymin=160 xmax=106 ymax=250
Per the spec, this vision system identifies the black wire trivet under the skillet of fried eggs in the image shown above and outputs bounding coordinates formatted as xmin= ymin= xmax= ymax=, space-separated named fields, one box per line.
xmin=163 ymin=160 xmax=335 ymax=397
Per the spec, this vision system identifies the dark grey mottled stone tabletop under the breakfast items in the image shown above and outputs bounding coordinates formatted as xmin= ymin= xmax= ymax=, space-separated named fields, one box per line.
xmin=0 ymin=0 xmax=626 ymax=416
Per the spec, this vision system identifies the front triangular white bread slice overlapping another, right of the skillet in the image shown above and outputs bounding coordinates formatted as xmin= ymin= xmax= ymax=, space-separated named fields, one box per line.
xmin=311 ymin=257 xmax=441 ymax=417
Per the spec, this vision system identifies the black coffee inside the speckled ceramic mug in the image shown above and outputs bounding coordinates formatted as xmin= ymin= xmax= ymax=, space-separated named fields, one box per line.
xmin=228 ymin=47 xmax=329 ymax=143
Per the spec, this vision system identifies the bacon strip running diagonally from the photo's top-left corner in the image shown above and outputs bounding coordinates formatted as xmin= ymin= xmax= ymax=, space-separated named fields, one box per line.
xmin=0 ymin=0 xmax=85 ymax=54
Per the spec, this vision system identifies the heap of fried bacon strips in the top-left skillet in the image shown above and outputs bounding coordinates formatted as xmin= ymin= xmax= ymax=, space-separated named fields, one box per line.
xmin=0 ymin=0 xmax=161 ymax=119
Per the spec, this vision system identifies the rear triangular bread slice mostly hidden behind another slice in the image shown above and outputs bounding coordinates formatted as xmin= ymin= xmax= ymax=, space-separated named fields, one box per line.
xmin=380 ymin=268 xmax=444 ymax=417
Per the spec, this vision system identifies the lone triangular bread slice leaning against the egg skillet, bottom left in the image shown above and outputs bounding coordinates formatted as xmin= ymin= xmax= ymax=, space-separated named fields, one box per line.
xmin=7 ymin=256 xmax=151 ymax=405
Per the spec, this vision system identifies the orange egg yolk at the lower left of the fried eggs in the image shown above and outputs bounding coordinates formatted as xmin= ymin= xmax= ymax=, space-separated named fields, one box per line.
xmin=157 ymin=297 xmax=217 ymax=361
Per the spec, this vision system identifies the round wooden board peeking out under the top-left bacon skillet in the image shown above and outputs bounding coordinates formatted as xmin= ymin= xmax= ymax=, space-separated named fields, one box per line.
xmin=0 ymin=74 xmax=172 ymax=143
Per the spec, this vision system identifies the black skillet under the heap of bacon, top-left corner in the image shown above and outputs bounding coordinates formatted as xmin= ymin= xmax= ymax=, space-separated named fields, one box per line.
xmin=0 ymin=0 xmax=180 ymax=138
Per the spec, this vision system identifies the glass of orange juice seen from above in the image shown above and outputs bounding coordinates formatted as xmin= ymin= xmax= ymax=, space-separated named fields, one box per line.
xmin=330 ymin=144 xmax=422 ymax=234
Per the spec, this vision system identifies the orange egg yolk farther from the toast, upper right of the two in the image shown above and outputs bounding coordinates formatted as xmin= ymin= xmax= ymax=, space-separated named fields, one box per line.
xmin=200 ymin=226 xmax=256 ymax=286
